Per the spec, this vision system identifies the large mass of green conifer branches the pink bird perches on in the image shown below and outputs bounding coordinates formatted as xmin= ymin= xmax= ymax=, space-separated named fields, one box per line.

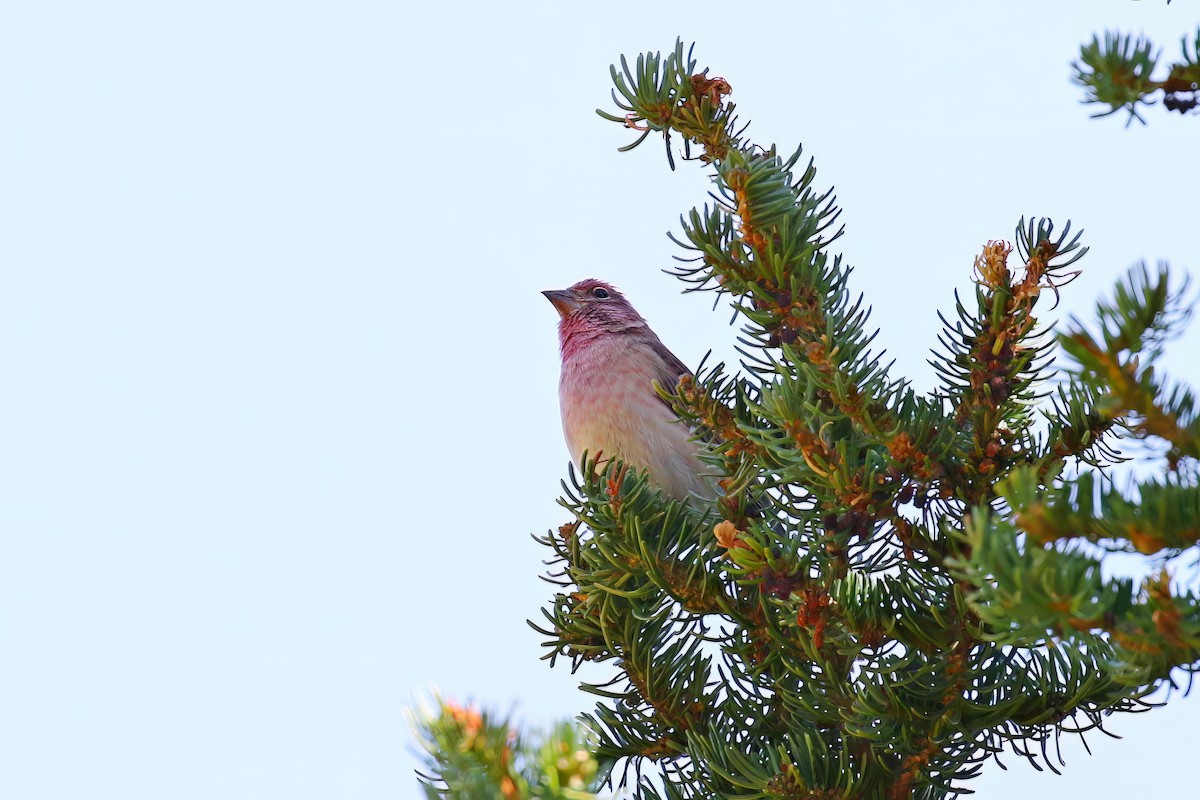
xmin=536 ymin=38 xmax=1200 ymax=798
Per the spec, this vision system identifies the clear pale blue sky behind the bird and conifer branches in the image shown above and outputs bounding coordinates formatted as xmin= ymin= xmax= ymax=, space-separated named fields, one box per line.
xmin=0 ymin=0 xmax=1200 ymax=800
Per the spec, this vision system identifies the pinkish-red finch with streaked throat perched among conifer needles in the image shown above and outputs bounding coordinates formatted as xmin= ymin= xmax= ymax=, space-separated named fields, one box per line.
xmin=542 ymin=278 xmax=719 ymax=500
